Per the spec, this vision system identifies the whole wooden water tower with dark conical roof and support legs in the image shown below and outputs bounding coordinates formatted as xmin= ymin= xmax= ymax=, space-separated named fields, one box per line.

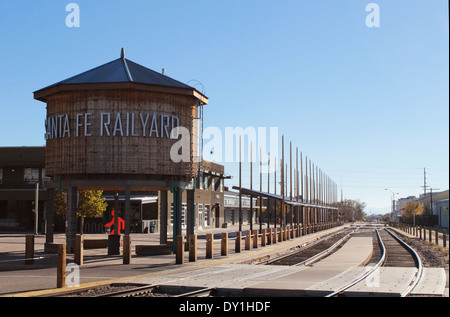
xmin=34 ymin=49 xmax=221 ymax=250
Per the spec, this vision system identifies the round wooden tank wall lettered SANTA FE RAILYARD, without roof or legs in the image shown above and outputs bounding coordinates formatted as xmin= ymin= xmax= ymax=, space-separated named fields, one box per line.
xmin=46 ymin=89 xmax=198 ymax=176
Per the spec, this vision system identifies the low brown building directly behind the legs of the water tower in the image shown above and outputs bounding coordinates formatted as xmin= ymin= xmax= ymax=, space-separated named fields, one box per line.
xmin=0 ymin=147 xmax=227 ymax=233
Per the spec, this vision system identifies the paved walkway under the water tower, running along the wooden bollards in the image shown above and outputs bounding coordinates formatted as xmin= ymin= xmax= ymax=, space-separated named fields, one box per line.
xmin=0 ymin=226 xmax=341 ymax=296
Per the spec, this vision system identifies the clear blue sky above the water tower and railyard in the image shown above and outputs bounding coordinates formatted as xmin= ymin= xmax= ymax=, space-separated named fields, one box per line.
xmin=0 ymin=0 xmax=449 ymax=212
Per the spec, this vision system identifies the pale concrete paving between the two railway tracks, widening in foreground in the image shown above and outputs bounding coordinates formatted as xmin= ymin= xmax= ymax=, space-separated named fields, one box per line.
xmin=128 ymin=237 xmax=372 ymax=297
